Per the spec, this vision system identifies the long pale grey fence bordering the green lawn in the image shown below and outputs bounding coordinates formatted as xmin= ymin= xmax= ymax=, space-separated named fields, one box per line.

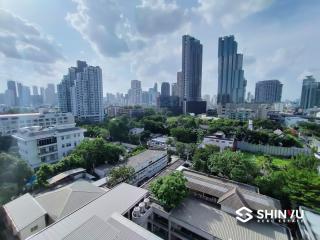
xmin=236 ymin=141 xmax=312 ymax=157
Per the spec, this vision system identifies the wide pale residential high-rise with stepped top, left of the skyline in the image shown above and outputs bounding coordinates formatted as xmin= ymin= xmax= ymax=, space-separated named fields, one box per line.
xmin=58 ymin=61 xmax=104 ymax=122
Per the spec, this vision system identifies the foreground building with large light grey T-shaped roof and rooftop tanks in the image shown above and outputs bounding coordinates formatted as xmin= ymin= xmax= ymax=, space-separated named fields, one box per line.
xmin=28 ymin=183 xmax=161 ymax=240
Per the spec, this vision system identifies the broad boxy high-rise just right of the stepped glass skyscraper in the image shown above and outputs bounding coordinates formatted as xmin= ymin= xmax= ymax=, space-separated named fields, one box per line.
xmin=255 ymin=80 xmax=283 ymax=103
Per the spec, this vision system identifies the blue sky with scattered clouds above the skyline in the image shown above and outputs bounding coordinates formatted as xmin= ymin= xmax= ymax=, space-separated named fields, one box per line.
xmin=0 ymin=0 xmax=320 ymax=100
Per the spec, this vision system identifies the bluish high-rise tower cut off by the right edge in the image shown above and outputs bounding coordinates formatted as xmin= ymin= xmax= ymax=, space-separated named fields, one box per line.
xmin=300 ymin=76 xmax=320 ymax=109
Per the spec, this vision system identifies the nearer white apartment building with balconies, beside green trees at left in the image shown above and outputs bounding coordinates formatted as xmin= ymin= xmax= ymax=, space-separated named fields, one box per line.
xmin=13 ymin=123 xmax=85 ymax=169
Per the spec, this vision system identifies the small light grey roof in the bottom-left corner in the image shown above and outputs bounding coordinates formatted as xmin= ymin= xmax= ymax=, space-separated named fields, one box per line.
xmin=3 ymin=193 xmax=47 ymax=232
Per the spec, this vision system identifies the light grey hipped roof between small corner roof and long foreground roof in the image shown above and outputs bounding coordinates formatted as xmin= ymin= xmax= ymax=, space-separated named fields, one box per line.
xmin=36 ymin=181 xmax=106 ymax=221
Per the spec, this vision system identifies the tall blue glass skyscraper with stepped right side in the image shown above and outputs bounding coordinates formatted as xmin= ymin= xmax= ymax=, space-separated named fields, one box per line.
xmin=217 ymin=36 xmax=246 ymax=104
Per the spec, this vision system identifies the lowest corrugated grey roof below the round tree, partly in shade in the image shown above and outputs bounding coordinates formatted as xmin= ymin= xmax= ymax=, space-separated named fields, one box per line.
xmin=170 ymin=197 xmax=289 ymax=240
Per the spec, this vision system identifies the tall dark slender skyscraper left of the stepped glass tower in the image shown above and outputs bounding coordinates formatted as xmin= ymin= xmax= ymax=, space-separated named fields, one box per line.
xmin=182 ymin=35 xmax=202 ymax=101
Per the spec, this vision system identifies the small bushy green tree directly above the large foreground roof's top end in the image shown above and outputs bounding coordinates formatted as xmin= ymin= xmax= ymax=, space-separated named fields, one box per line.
xmin=108 ymin=166 xmax=135 ymax=187
